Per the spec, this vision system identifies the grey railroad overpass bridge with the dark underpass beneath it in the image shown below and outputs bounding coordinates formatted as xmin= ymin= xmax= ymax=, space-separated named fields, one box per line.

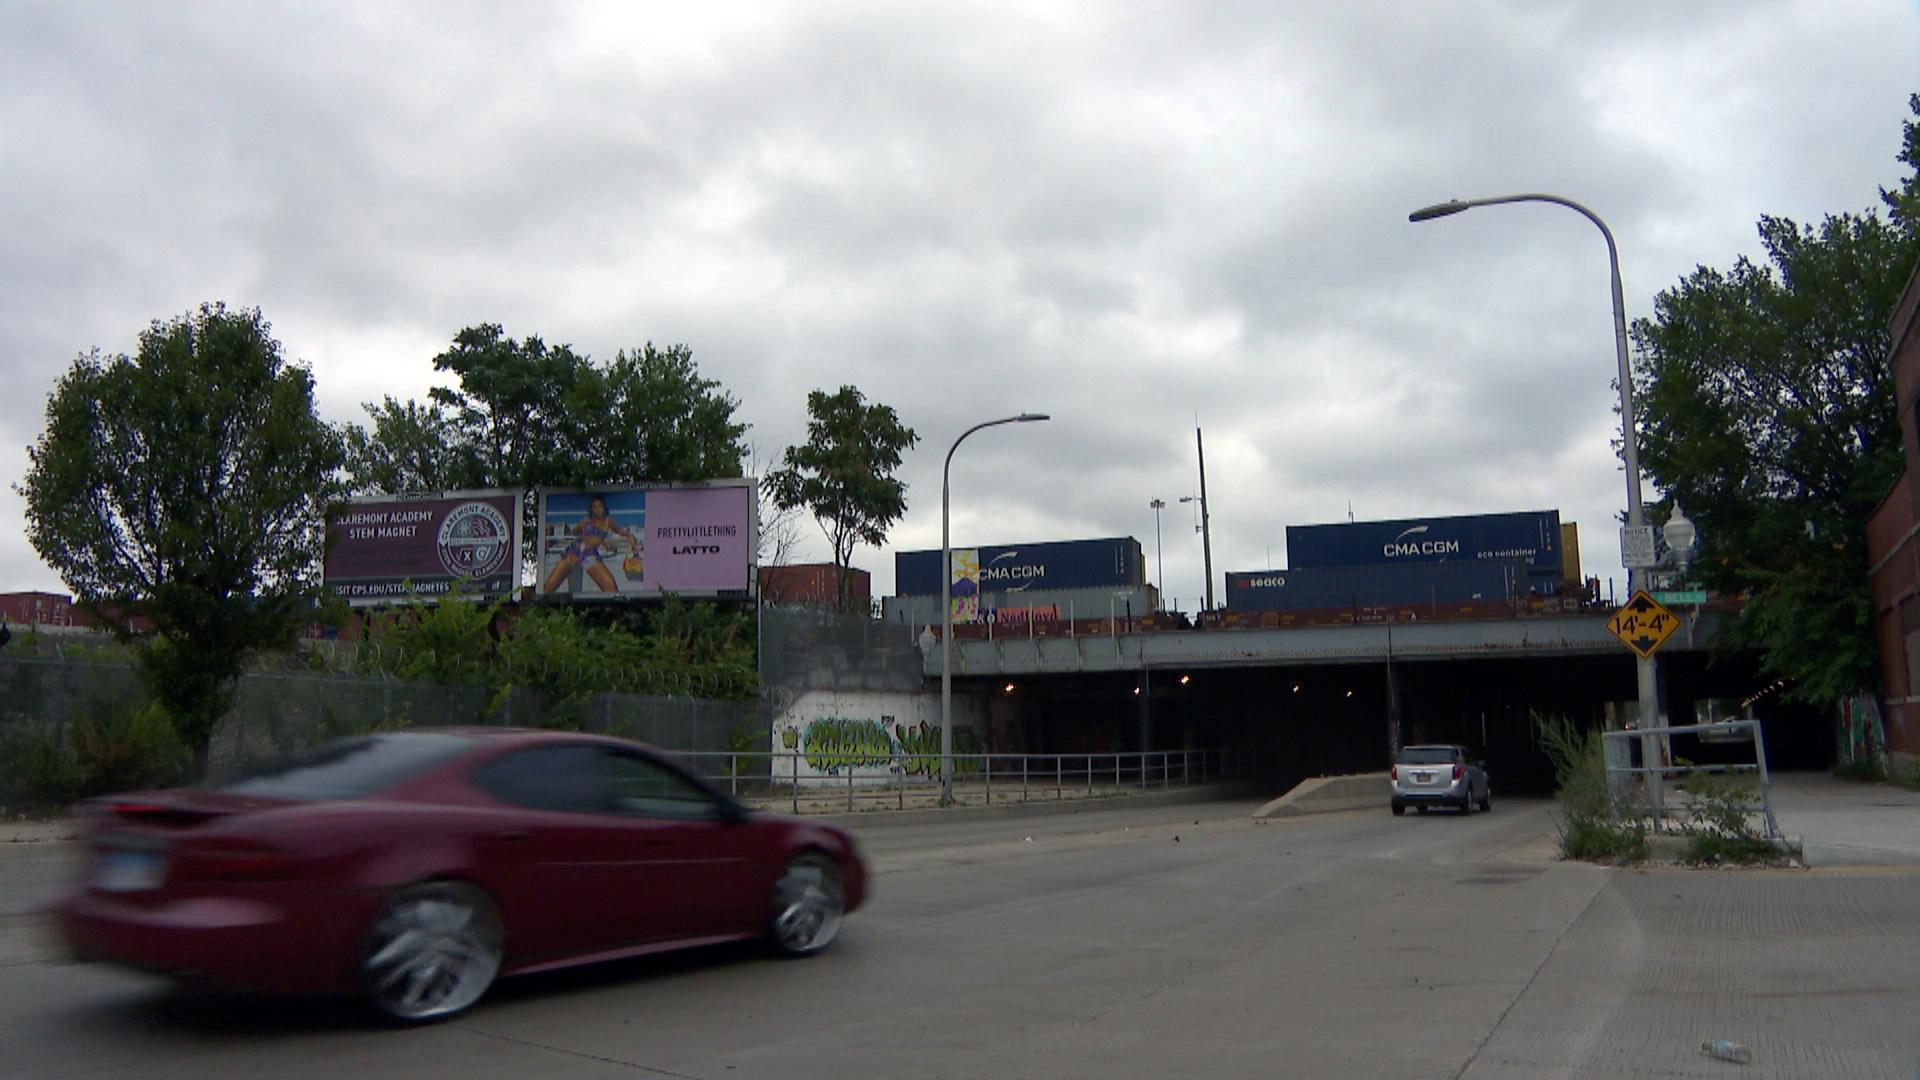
xmin=922 ymin=609 xmax=1826 ymax=792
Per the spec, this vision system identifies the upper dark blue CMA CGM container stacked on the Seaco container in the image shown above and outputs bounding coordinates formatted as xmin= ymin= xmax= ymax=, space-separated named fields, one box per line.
xmin=1286 ymin=509 xmax=1561 ymax=578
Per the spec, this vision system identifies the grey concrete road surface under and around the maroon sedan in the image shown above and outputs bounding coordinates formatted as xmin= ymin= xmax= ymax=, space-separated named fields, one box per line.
xmin=0 ymin=801 xmax=1920 ymax=1080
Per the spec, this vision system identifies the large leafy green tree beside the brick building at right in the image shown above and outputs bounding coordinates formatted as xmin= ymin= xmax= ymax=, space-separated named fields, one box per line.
xmin=1634 ymin=96 xmax=1920 ymax=703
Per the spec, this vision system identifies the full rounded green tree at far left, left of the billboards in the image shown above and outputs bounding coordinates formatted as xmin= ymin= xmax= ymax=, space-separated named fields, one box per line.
xmin=17 ymin=304 xmax=344 ymax=769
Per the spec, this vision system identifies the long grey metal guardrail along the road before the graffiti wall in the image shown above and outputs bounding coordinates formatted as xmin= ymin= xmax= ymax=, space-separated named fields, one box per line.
xmin=666 ymin=749 xmax=1246 ymax=813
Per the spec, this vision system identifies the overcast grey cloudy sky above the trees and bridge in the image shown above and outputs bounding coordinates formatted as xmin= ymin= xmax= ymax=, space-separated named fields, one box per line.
xmin=0 ymin=0 xmax=1920 ymax=609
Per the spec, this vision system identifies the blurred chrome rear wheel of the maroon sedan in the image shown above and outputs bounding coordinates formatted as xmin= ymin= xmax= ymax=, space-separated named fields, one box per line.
xmin=361 ymin=882 xmax=501 ymax=1022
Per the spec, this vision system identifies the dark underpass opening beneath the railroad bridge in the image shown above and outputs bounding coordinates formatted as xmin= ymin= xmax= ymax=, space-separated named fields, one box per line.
xmin=954 ymin=650 xmax=1832 ymax=796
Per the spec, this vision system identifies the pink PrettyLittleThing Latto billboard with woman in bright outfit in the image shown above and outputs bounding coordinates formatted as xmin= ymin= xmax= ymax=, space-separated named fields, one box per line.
xmin=536 ymin=480 xmax=758 ymax=600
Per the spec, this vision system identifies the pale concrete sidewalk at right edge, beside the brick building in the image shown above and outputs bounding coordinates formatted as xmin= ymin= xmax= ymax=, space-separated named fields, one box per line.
xmin=1772 ymin=773 xmax=1920 ymax=867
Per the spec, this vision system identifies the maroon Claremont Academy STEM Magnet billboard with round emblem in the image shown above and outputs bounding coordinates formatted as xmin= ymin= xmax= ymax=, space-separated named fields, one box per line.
xmin=321 ymin=492 xmax=520 ymax=605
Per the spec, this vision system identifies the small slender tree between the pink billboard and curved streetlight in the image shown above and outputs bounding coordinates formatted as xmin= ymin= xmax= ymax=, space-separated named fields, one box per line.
xmin=766 ymin=386 xmax=920 ymax=611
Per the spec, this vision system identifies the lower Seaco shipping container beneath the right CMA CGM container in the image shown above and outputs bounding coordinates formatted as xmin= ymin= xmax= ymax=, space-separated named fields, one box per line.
xmin=1227 ymin=559 xmax=1526 ymax=611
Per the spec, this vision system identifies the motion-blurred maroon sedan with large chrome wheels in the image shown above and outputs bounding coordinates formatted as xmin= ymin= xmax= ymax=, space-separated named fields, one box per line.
xmin=60 ymin=728 xmax=866 ymax=1020
